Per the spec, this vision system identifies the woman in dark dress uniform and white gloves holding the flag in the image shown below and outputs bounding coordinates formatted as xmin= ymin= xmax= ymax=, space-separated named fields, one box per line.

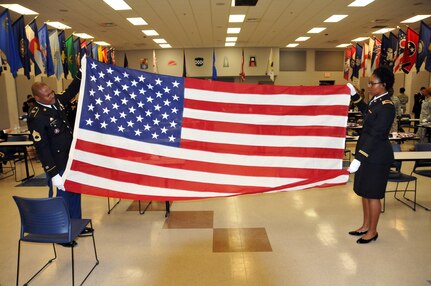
xmin=348 ymin=67 xmax=395 ymax=244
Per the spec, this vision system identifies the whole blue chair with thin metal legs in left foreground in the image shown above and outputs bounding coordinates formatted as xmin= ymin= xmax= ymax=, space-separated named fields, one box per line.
xmin=13 ymin=196 xmax=99 ymax=286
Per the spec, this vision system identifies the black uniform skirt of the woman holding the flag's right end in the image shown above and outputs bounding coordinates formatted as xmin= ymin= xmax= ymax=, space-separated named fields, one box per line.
xmin=353 ymin=161 xmax=391 ymax=199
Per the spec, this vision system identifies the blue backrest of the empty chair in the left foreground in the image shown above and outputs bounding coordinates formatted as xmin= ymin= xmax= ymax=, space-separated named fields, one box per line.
xmin=13 ymin=196 xmax=71 ymax=238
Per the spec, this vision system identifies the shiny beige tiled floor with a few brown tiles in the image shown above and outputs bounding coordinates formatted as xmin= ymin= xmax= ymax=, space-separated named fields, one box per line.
xmin=0 ymin=141 xmax=431 ymax=286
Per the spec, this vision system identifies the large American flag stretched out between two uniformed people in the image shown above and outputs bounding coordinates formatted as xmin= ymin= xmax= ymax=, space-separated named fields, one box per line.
xmin=64 ymin=58 xmax=350 ymax=200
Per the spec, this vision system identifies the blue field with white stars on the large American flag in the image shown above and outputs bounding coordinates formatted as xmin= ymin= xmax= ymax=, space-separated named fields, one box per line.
xmin=79 ymin=58 xmax=184 ymax=147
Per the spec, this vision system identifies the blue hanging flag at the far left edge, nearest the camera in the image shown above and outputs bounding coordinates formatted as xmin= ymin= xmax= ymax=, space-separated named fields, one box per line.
xmin=0 ymin=9 xmax=22 ymax=77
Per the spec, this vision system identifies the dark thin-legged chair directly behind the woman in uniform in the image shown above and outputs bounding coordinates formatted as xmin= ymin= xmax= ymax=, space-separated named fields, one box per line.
xmin=381 ymin=144 xmax=417 ymax=213
